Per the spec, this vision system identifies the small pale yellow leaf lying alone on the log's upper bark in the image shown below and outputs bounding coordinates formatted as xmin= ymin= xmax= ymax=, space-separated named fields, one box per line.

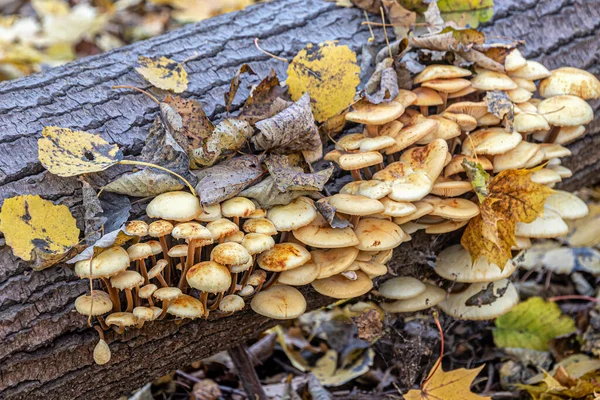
xmin=135 ymin=56 xmax=188 ymax=93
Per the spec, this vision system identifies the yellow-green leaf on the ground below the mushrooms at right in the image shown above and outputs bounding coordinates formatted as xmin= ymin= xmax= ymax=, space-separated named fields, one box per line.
xmin=493 ymin=297 xmax=576 ymax=351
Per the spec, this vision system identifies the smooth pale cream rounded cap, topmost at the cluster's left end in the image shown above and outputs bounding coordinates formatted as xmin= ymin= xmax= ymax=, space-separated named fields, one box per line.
xmin=146 ymin=192 xmax=202 ymax=221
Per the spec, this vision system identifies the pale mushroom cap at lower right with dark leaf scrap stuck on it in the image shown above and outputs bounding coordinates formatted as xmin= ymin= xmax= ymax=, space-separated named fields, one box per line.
xmin=438 ymin=279 xmax=519 ymax=321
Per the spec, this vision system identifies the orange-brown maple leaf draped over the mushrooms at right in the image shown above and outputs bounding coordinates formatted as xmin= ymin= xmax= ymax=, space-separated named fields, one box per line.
xmin=461 ymin=167 xmax=554 ymax=268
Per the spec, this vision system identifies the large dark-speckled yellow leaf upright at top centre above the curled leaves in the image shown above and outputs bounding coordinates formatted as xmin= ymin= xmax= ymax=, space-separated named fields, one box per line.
xmin=286 ymin=41 xmax=360 ymax=122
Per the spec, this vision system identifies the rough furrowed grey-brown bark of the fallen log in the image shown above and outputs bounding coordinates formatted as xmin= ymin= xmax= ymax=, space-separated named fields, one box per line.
xmin=0 ymin=0 xmax=600 ymax=399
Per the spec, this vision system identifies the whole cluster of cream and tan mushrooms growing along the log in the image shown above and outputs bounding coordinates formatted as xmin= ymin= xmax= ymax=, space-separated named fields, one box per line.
xmin=75 ymin=50 xmax=600 ymax=363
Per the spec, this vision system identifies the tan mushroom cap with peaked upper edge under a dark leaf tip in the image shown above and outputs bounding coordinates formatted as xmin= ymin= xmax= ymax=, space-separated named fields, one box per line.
xmin=292 ymin=214 xmax=358 ymax=249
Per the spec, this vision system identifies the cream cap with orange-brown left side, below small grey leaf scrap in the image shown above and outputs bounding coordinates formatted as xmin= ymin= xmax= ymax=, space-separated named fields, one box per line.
xmin=462 ymin=128 xmax=523 ymax=156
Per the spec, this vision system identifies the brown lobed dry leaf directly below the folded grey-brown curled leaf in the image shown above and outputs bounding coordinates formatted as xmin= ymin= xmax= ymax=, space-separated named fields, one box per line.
xmin=265 ymin=154 xmax=333 ymax=192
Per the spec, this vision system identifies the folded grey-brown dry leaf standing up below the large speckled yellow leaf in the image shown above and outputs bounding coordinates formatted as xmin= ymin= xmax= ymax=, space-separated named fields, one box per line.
xmin=252 ymin=94 xmax=322 ymax=154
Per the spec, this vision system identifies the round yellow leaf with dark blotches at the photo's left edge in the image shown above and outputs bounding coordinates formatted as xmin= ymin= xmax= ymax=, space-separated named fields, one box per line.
xmin=0 ymin=195 xmax=79 ymax=266
